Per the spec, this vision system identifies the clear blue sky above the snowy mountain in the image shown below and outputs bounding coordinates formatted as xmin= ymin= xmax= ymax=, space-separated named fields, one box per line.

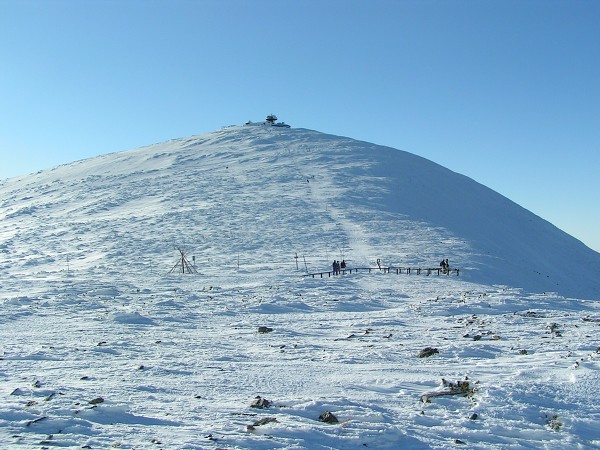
xmin=0 ymin=0 xmax=600 ymax=251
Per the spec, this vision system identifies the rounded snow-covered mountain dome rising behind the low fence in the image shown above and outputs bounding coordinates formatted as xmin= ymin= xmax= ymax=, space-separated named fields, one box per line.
xmin=0 ymin=125 xmax=600 ymax=298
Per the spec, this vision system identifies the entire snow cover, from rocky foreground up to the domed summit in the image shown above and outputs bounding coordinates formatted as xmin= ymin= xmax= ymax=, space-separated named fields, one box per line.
xmin=0 ymin=125 xmax=600 ymax=449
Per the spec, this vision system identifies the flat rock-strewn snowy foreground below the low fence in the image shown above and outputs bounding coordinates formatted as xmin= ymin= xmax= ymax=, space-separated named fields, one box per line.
xmin=0 ymin=273 xmax=600 ymax=449
